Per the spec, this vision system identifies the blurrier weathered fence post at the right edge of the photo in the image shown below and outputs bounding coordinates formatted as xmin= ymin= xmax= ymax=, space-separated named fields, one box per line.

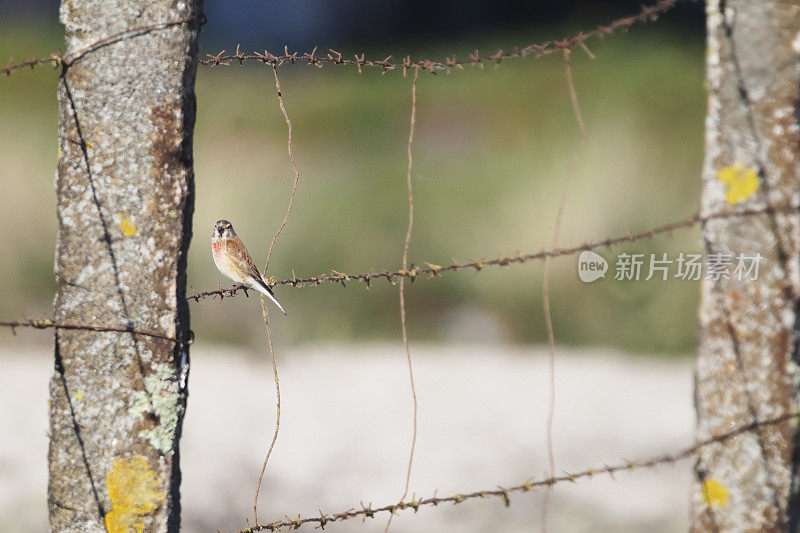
xmin=693 ymin=0 xmax=800 ymax=531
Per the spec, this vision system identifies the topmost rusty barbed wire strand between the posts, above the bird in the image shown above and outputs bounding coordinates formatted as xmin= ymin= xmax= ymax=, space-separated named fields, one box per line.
xmin=200 ymin=0 xmax=688 ymax=74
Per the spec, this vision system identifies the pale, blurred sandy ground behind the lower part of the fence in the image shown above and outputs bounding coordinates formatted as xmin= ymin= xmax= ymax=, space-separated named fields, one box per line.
xmin=0 ymin=339 xmax=694 ymax=533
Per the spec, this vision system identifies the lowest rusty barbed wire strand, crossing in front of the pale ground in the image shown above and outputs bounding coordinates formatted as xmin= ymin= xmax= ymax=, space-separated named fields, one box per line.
xmin=239 ymin=412 xmax=800 ymax=533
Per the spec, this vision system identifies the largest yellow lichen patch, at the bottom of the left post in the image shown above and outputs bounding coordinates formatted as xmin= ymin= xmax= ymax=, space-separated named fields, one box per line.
xmin=105 ymin=455 xmax=167 ymax=533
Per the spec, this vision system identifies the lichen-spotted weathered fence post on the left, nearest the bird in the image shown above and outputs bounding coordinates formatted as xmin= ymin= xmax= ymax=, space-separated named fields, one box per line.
xmin=48 ymin=0 xmax=202 ymax=532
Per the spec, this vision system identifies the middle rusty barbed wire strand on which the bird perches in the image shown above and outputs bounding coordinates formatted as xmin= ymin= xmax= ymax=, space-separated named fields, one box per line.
xmin=186 ymin=205 xmax=798 ymax=302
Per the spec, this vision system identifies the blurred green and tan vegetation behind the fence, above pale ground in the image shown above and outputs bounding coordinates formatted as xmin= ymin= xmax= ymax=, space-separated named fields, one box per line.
xmin=0 ymin=19 xmax=705 ymax=353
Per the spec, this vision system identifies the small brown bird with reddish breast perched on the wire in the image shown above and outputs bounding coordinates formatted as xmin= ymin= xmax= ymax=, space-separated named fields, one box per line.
xmin=211 ymin=220 xmax=286 ymax=315
